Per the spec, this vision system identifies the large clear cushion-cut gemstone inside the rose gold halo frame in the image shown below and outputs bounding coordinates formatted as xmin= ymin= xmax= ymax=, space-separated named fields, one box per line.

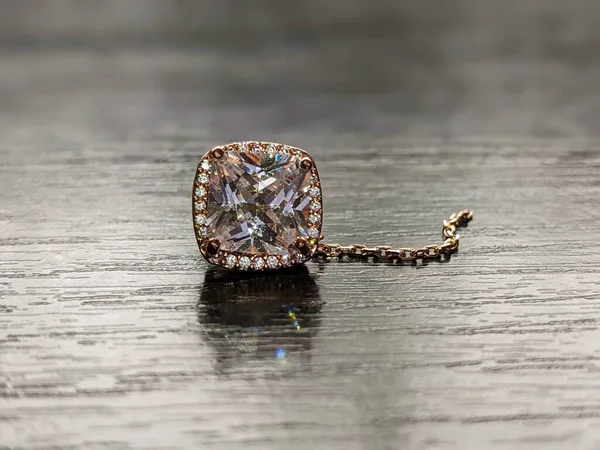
xmin=206 ymin=147 xmax=314 ymax=255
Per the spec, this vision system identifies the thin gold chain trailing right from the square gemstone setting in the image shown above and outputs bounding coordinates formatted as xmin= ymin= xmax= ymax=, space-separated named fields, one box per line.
xmin=315 ymin=209 xmax=473 ymax=261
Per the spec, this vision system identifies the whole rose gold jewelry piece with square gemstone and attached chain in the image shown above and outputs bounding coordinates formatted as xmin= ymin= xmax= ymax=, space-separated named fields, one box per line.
xmin=192 ymin=142 xmax=473 ymax=271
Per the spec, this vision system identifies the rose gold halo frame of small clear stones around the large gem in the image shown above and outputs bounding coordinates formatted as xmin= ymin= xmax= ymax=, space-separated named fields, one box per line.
xmin=192 ymin=141 xmax=323 ymax=271
